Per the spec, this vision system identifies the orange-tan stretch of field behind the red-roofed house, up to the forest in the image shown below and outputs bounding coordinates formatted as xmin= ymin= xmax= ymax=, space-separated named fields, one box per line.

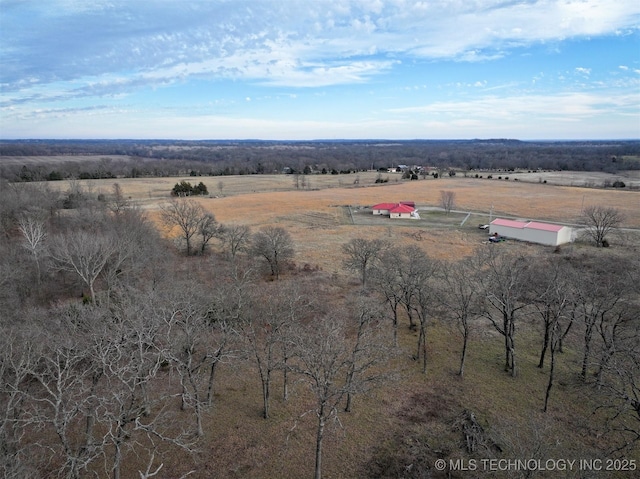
xmin=49 ymin=172 xmax=640 ymax=227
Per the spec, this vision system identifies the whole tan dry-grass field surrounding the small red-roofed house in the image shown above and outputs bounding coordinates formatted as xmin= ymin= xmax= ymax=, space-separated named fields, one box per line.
xmin=49 ymin=172 xmax=640 ymax=272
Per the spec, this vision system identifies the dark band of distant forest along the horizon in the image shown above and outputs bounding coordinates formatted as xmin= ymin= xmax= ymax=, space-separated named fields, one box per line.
xmin=0 ymin=140 xmax=640 ymax=181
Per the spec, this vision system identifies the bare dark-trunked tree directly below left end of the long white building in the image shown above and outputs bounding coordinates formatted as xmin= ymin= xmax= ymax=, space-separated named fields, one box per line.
xmin=479 ymin=247 xmax=530 ymax=377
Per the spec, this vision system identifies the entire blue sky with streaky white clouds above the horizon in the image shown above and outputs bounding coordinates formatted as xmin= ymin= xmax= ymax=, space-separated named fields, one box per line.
xmin=0 ymin=0 xmax=640 ymax=140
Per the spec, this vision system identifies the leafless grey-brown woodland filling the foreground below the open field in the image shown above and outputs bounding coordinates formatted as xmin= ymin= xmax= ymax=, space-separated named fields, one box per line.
xmin=0 ymin=160 xmax=640 ymax=479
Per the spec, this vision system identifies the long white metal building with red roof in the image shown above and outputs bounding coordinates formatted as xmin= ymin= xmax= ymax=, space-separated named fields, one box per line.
xmin=489 ymin=218 xmax=573 ymax=246
